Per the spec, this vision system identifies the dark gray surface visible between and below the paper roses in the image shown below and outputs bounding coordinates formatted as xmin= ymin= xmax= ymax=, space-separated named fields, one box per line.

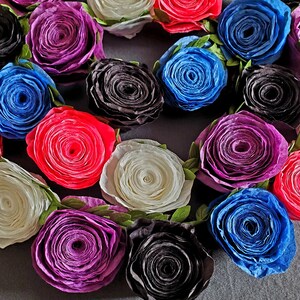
xmin=0 ymin=1 xmax=300 ymax=300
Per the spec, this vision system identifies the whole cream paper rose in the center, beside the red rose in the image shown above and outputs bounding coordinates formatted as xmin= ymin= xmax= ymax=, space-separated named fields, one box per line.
xmin=100 ymin=139 xmax=194 ymax=213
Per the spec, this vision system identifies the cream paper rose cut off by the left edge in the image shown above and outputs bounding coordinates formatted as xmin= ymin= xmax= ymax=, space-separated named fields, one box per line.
xmin=0 ymin=158 xmax=59 ymax=249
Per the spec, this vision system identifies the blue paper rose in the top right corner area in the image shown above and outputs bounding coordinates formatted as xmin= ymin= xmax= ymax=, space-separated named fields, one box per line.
xmin=218 ymin=0 xmax=291 ymax=65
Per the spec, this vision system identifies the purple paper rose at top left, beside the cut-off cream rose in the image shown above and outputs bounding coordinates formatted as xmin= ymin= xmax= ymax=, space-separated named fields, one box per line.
xmin=26 ymin=1 xmax=104 ymax=81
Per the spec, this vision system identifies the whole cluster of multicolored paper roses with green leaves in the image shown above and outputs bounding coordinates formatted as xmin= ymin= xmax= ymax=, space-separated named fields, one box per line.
xmin=0 ymin=0 xmax=300 ymax=299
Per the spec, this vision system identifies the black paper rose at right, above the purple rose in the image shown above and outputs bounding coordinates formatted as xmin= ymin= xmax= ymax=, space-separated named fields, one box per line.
xmin=239 ymin=65 xmax=300 ymax=127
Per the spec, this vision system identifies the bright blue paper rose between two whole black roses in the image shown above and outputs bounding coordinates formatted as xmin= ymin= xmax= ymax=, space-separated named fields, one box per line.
xmin=156 ymin=36 xmax=228 ymax=111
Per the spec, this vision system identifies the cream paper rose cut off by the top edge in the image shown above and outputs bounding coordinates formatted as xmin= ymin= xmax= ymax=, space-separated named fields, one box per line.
xmin=87 ymin=0 xmax=155 ymax=39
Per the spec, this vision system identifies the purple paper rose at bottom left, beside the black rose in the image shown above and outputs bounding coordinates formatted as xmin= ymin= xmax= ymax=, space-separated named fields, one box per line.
xmin=31 ymin=209 xmax=126 ymax=293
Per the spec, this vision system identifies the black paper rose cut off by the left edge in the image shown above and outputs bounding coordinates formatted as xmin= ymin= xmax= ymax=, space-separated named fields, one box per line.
xmin=0 ymin=5 xmax=23 ymax=68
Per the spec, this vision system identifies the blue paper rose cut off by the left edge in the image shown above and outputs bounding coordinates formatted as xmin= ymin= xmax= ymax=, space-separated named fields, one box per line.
xmin=0 ymin=60 xmax=63 ymax=139
